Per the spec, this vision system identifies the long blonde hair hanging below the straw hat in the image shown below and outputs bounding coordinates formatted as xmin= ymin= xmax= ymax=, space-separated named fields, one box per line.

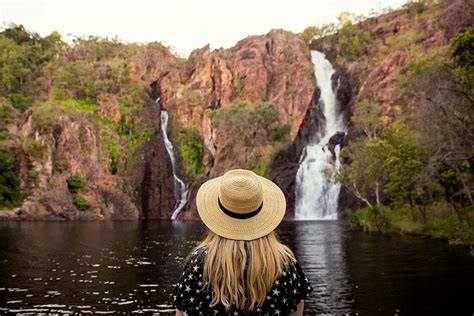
xmin=192 ymin=231 xmax=294 ymax=311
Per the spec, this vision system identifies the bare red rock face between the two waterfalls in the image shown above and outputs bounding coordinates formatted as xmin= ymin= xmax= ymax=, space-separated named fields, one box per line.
xmin=159 ymin=30 xmax=315 ymax=218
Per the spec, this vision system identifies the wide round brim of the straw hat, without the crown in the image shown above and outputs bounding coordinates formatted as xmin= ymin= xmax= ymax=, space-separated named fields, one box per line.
xmin=196 ymin=176 xmax=286 ymax=240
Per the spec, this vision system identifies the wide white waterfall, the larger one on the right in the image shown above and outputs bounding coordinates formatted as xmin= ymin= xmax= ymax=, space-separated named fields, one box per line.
xmin=295 ymin=51 xmax=345 ymax=220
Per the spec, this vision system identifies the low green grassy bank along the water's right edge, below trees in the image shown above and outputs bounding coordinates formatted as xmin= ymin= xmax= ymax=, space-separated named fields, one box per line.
xmin=348 ymin=203 xmax=474 ymax=255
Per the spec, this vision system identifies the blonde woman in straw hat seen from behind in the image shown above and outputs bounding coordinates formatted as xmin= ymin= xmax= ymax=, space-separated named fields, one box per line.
xmin=174 ymin=169 xmax=312 ymax=315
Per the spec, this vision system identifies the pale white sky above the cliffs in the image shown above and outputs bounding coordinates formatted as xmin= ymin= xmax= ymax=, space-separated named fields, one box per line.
xmin=0 ymin=0 xmax=407 ymax=57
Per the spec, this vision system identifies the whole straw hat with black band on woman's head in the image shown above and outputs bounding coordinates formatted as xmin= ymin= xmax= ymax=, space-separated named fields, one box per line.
xmin=196 ymin=169 xmax=286 ymax=240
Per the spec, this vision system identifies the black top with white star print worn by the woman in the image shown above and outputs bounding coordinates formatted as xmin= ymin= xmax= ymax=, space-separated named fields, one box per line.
xmin=173 ymin=249 xmax=313 ymax=316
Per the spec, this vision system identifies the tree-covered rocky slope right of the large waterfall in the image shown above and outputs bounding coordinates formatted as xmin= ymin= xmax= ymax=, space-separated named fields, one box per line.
xmin=317 ymin=1 xmax=474 ymax=245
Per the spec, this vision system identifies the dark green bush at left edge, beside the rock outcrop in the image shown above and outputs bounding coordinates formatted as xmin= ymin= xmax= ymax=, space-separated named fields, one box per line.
xmin=0 ymin=146 xmax=20 ymax=208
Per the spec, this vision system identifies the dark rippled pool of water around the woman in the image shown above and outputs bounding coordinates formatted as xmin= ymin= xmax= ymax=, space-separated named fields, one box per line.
xmin=0 ymin=221 xmax=474 ymax=315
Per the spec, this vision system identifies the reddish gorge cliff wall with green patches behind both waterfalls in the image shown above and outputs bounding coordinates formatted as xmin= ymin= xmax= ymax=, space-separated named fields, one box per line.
xmin=0 ymin=0 xmax=474 ymax=220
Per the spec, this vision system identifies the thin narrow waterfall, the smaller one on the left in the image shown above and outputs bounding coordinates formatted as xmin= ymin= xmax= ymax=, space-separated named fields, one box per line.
xmin=156 ymin=110 xmax=189 ymax=219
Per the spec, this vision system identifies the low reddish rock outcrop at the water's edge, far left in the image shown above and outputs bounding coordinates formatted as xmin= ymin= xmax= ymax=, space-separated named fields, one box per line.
xmin=10 ymin=106 xmax=140 ymax=220
